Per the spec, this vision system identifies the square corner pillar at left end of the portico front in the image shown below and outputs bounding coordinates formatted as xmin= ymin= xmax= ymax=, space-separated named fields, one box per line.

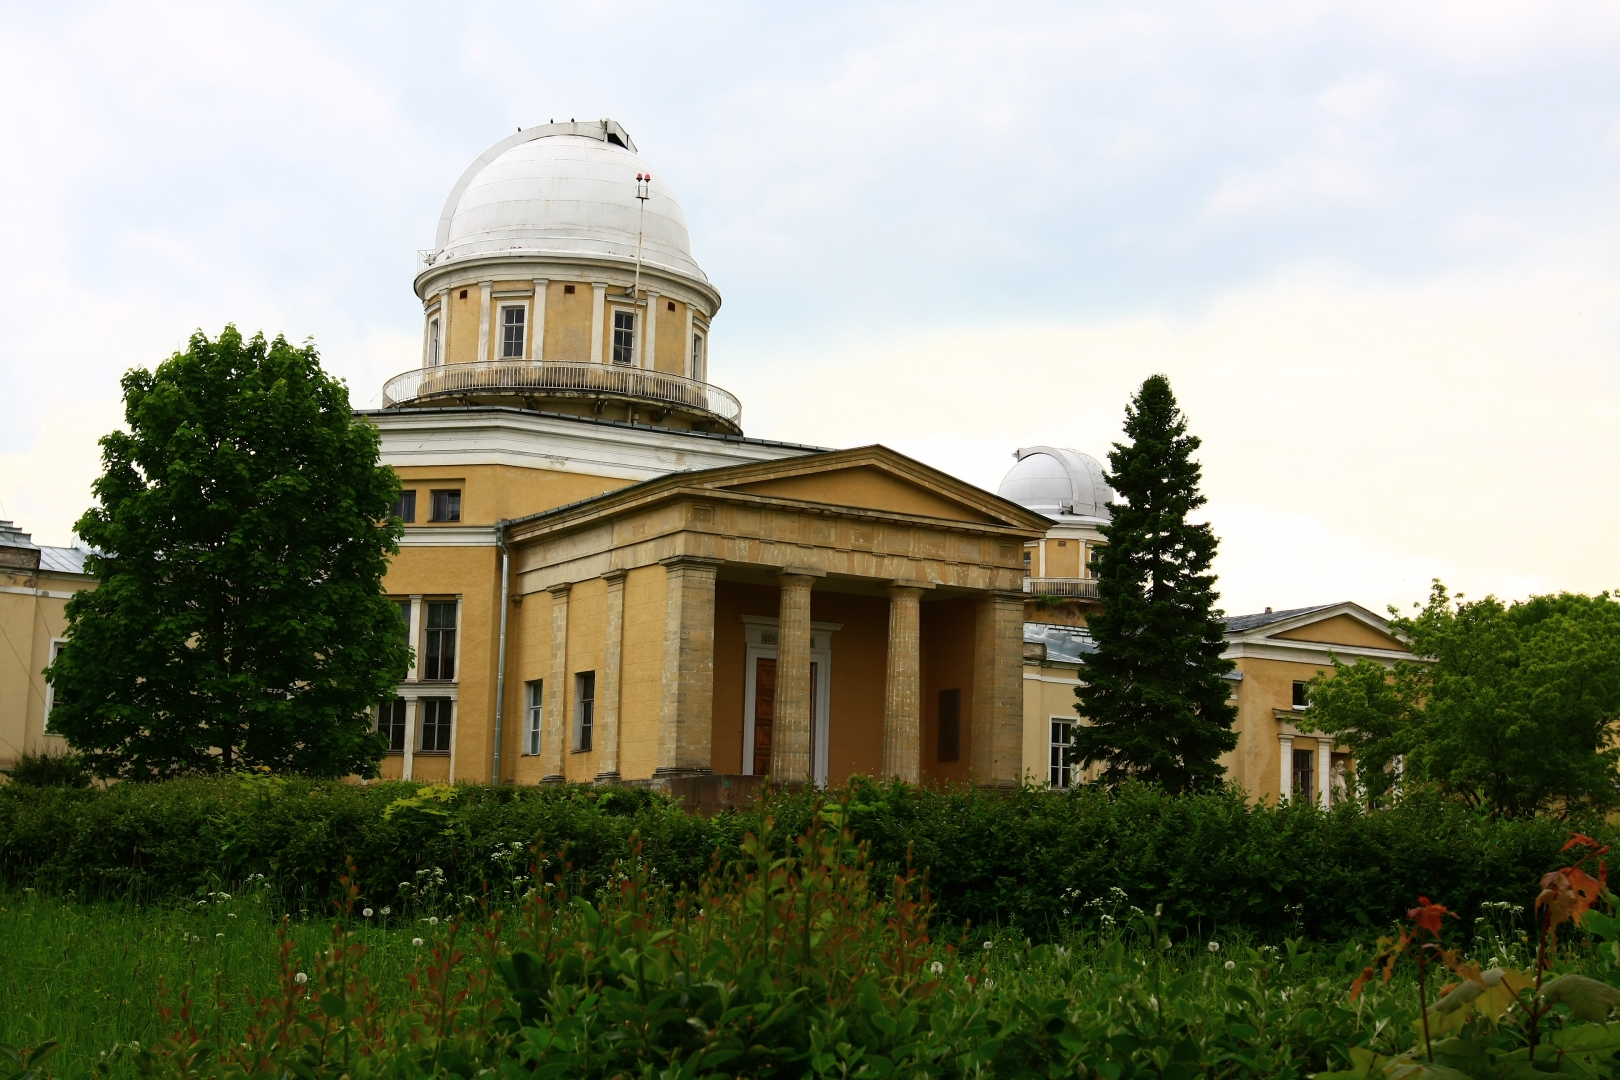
xmin=654 ymin=555 xmax=721 ymax=776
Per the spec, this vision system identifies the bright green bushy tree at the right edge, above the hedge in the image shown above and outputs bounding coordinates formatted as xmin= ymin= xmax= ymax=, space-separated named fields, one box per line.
xmin=1304 ymin=581 xmax=1620 ymax=816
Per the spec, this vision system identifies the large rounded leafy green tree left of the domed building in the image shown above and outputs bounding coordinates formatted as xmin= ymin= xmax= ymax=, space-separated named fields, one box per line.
xmin=47 ymin=325 xmax=410 ymax=779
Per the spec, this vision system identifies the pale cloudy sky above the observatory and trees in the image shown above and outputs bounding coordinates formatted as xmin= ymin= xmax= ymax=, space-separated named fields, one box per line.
xmin=0 ymin=0 xmax=1620 ymax=614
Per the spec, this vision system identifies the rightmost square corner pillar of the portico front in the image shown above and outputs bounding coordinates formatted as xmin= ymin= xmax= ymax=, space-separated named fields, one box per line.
xmin=972 ymin=593 xmax=1024 ymax=787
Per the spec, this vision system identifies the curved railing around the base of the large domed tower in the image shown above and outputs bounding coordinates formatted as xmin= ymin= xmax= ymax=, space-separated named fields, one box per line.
xmin=382 ymin=359 xmax=742 ymax=426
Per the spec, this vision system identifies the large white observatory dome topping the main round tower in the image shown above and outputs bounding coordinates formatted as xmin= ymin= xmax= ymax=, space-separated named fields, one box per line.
xmin=433 ymin=120 xmax=708 ymax=283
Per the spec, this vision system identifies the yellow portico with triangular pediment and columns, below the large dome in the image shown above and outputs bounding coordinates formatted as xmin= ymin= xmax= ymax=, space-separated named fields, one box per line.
xmin=502 ymin=447 xmax=1048 ymax=785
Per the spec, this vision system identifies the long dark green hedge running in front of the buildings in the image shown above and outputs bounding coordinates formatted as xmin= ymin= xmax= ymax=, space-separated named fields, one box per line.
xmin=0 ymin=777 xmax=1594 ymax=938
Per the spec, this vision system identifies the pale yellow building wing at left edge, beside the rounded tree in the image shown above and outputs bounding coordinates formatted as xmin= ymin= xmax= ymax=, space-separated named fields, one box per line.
xmin=0 ymin=521 xmax=96 ymax=769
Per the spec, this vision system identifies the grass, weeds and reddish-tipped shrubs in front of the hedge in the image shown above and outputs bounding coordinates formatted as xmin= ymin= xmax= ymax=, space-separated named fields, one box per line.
xmin=9 ymin=798 xmax=1620 ymax=1080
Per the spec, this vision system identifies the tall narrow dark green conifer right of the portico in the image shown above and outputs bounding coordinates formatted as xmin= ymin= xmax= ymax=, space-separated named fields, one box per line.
xmin=1071 ymin=376 xmax=1238 ymax=790
